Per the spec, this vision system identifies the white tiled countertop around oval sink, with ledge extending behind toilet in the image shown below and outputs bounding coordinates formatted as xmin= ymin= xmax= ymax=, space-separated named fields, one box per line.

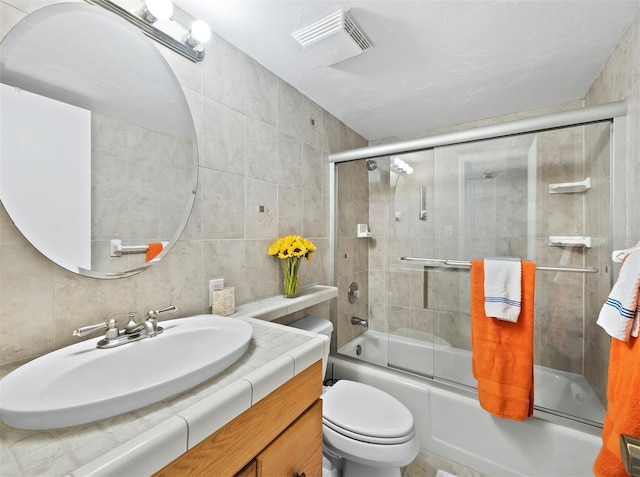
xmin=0 ymin=286 xmax=337 ymax=477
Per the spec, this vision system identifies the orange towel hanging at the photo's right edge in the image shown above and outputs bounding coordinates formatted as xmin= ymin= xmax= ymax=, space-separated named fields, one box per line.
xmin=593 ymin=338 xmax=640 ymax=477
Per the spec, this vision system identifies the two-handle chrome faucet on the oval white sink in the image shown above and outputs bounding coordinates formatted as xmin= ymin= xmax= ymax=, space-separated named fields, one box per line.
xmin=73 ymin=305 xmax=178 ymax=349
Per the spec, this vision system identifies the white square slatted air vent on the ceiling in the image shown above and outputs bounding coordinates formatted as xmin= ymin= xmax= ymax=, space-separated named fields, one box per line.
xmin=293 ymin=10 xmax=373 ymax=66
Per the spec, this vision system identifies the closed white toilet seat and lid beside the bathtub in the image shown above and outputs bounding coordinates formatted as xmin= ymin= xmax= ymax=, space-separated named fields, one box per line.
xmin=322 ymin=380 xmax=415 ymax=445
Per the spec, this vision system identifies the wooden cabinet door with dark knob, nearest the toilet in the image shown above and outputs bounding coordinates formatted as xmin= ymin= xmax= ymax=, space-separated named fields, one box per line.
xmin=256 ymin=400 xmax=322 ymax=477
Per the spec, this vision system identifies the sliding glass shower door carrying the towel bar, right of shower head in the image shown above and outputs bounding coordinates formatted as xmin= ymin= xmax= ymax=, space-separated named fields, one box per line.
xmin=388 ymin=123 xmax=610 ymax=423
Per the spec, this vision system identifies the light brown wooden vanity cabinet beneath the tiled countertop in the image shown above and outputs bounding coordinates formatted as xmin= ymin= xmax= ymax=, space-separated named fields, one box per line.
xmin=156 ymin=361 xmax=322 ymax=477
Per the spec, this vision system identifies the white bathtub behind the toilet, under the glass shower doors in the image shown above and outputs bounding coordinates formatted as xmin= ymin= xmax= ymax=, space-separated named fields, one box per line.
xmin=327 ymin=330 xmax=601 ymax=477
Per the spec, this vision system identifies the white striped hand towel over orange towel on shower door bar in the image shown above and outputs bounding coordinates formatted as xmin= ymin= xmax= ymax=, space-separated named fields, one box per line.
xmin=484 ymin=258 xmax=522 ymax=323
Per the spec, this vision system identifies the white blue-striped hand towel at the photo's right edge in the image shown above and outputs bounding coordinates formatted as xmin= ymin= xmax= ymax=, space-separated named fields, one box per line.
xmin=597 ymin=250 xmax=640 ymax=341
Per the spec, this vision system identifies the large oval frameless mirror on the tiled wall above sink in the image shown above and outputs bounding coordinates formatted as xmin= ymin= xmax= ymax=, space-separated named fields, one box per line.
xmin=0 ymin=3 xmax=198 ymax=278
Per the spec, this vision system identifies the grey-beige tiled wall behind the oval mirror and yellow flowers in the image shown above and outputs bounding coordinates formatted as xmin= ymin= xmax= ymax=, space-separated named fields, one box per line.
xmin=0 ymin=0 xmax=367 ymax=364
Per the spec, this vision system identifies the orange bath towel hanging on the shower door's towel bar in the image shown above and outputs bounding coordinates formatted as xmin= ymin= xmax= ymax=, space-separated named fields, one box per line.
xmin=471 ymin=260 xmax=536 ymax=421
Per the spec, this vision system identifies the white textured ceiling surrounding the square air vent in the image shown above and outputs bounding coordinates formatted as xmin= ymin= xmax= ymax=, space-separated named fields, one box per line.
xmin=175 ymin=0 xmax=640 ymax=140
